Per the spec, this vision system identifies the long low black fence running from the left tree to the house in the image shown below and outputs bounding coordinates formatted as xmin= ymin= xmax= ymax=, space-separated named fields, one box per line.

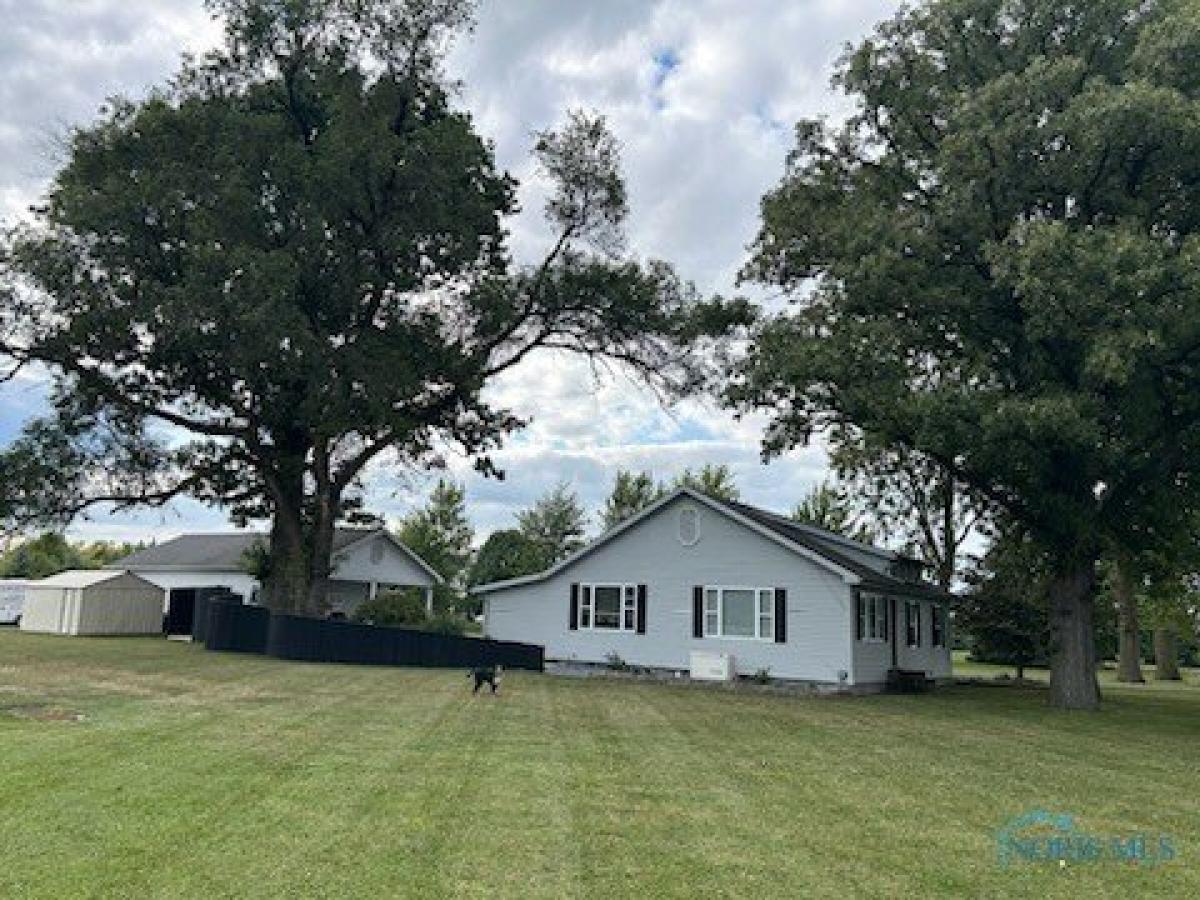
xmin=205 ymin=602 xmax=545 ymax=672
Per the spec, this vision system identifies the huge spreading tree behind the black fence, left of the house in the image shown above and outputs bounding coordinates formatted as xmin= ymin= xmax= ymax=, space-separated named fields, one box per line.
xmin=0 ymin=0 xmax=731 ymax=612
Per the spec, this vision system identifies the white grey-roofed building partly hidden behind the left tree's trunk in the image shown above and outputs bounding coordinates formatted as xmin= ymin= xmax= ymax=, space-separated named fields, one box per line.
xmin=108 ymin=528 xmax=442 ymax=634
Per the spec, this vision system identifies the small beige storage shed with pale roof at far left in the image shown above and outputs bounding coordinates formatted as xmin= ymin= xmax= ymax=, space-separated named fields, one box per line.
xmin=20 ymin=569 xmax=163 ymax=635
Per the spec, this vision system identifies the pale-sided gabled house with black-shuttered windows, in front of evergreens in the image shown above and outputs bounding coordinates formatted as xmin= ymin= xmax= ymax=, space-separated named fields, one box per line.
xmin=476 ymin=488 xmax=952 ymax=690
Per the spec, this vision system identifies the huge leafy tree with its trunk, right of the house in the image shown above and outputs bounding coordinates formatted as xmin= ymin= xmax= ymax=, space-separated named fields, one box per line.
xmin=730 ymin=0 xmax=1200 ymax=708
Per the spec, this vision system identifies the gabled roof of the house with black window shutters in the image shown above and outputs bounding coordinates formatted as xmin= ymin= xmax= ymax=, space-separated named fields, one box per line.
xmin=473 ymin=487 xmax=946 ymax=599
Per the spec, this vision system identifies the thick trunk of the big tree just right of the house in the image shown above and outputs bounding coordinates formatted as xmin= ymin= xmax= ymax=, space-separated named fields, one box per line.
xmin=1050 ymin=556 xmax=1100 ymax=709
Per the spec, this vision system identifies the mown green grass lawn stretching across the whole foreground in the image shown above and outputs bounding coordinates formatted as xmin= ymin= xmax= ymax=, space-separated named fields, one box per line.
xmin=0 ymin=630 xmax=1200 ymax=899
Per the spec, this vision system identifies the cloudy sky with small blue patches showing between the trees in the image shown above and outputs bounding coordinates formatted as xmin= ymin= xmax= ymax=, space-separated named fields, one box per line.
xmin=0 ymin=0 xmax=898 ymax=539
